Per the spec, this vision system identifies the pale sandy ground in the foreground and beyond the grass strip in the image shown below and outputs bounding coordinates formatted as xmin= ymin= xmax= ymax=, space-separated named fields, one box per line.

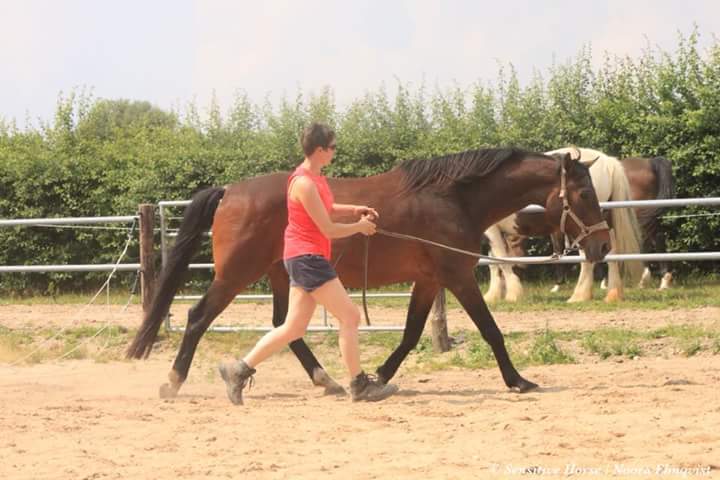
xmin=0 ymin=306 xmax=720 ymax=480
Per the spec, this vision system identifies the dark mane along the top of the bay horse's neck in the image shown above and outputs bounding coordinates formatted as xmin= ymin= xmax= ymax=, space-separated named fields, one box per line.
xmin=397 ymin=148 xmax=542 ymax=192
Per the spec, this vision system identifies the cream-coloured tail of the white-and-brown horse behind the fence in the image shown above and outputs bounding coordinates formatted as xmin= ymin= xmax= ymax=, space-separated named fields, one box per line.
xmin=610 ymin=161 xmax=643 ymax=282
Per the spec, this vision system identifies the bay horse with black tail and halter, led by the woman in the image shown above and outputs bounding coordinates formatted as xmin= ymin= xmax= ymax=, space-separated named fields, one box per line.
xmin=127 ymin=148 xmax=610 ymax=398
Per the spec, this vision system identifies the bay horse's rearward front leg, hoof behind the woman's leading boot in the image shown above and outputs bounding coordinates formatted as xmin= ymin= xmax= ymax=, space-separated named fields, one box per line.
xmin=377 ymin=280 xmax=440 ymax=383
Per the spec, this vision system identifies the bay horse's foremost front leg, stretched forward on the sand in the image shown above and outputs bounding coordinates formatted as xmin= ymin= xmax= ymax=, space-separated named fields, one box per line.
xmin=447 ymin=271 xmax=538 ymax=393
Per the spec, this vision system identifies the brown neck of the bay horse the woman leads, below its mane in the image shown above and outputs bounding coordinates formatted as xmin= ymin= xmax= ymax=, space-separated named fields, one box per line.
xmin=470 ymin=157 xmax=560 ymax=226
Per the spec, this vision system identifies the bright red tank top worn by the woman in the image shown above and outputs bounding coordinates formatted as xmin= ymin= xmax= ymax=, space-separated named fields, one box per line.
xmin=283 ymin=166 xmax=334 ymax=260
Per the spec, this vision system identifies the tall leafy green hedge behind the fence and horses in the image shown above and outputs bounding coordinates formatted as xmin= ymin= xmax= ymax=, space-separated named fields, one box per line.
xmin=0 ymin=32 xmax=720 ymax=295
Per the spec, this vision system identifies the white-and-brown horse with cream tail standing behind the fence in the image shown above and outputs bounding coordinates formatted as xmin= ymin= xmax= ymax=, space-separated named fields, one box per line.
xmin=485 ymin=147 xmax=643 ymax=302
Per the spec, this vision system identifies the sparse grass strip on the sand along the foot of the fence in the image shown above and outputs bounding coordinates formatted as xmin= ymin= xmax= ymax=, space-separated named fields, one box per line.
xmin=0 ymin=316 xmax=720 ymax=376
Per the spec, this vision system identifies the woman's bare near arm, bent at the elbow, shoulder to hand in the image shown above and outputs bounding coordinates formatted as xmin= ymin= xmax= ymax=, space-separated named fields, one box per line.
xmin=288 ymin=177 xmax=376 ymax=238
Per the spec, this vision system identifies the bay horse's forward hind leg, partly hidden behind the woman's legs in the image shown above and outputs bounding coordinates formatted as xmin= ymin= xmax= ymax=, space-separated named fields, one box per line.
xmin=268 ymin=262 xmax=347 ymax=395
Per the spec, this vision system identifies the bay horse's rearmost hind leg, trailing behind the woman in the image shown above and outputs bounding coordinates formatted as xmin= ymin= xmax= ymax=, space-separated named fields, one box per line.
xmin=159 ymin=279 xmax=245 ymax=398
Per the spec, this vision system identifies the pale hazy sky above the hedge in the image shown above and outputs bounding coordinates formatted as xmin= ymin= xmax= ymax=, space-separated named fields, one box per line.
xmin=0 ymin=0 xmax=720 ymax=127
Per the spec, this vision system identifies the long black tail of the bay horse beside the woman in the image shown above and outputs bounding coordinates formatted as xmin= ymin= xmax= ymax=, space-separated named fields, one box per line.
xmin=125 ymin=187 xmax=225 ymax=358
